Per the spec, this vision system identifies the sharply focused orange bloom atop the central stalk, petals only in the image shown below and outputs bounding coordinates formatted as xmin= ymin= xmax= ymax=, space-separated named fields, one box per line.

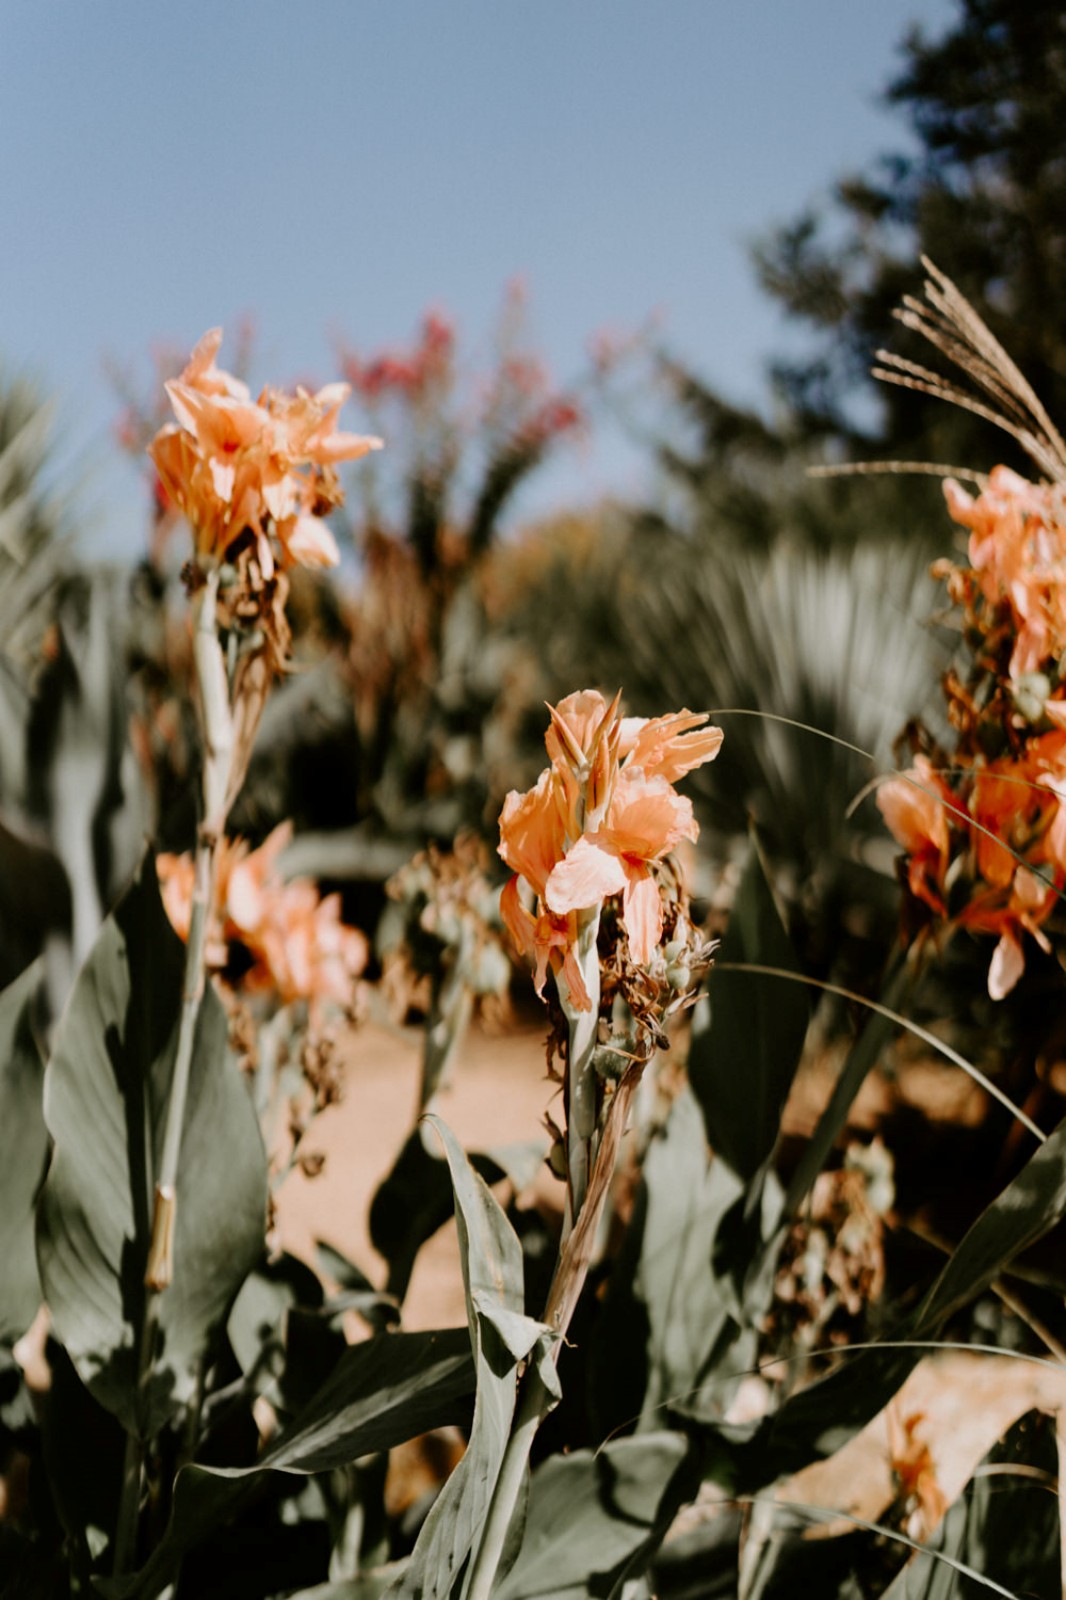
xmin=499 ymin=690 xmax=722 ymax=1011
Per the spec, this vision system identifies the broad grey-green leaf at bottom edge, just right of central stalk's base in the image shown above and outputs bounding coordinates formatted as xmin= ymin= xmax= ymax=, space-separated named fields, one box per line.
xmin=493 ymin=1432 xmax=698 ymax=1600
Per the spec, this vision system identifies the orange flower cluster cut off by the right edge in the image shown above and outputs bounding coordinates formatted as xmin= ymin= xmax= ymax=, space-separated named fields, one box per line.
xmin=877 ymin=467 xmax=1066 ymax=1000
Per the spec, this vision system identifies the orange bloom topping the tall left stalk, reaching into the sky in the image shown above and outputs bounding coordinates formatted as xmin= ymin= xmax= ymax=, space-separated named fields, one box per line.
xmin=149 ymin=328 xmax=381 ymax=579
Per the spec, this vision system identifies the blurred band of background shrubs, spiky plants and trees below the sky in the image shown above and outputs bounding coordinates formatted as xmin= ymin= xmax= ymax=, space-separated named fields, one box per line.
xmin=0 ymin=0 xmax=1066 ymax=998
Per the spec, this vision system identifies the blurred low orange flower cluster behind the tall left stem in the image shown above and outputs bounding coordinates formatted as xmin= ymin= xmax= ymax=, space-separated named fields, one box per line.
xmin=157 ymin=822 xmax=370 ymax=1005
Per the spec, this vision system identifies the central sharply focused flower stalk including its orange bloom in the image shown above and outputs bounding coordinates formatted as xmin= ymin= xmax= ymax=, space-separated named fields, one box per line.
xmin=466 ymin=691 xmax=722 ymax=1600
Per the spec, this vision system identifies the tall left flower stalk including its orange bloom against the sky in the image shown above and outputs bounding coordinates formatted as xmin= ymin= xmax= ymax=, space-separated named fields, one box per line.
xmin=114 ymin=328 xmax=381 ymax=1574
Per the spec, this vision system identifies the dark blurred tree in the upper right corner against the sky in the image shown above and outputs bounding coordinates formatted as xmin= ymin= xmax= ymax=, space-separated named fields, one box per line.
xmin=755 ymin=0 xmax=1066 ymax=464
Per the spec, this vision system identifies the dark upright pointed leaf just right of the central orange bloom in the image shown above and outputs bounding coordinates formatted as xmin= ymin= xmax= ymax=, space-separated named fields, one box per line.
xmin=688 ymin=842 xmax=808 ymax=1181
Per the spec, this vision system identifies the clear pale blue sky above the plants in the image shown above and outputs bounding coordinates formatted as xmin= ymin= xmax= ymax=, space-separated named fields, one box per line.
xmin=0 ymin=0 xmax=956 ymax=550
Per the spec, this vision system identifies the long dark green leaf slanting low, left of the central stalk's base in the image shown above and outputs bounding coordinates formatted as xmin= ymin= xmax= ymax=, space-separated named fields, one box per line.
xmin=101 ymin=1328 xmax=474 ymax=1600
